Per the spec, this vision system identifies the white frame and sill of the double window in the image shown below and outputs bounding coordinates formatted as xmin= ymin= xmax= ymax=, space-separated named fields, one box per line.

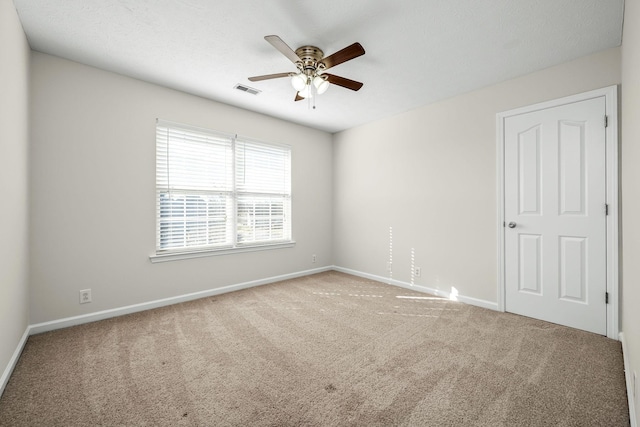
xmin=149 ymin=119 xmax=295 ymax=263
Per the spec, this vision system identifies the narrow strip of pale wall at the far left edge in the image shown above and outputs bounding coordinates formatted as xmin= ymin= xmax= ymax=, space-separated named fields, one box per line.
xmin=0 ymin=0 xmax=29 ymax=393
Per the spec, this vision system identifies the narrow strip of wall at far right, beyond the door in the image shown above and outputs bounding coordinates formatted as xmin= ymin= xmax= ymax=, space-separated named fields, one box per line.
xmin=620 ymin=1 xmax=640 ymax=422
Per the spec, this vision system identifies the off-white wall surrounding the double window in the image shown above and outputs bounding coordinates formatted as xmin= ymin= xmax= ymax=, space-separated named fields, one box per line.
xmin=31 ymin=52 xmax=332 ymax=323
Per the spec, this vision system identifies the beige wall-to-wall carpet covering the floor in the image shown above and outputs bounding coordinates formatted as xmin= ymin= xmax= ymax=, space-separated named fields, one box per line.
xmin=0 ymin=272 xmax=629 ymax=426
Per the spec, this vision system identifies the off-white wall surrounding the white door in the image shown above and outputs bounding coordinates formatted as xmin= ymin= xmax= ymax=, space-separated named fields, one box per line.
xmin=333 ymin=48 xmax=620 ymax=303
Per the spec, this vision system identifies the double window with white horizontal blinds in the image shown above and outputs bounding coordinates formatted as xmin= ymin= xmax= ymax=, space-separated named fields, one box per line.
xmin=156 ymin=120 xmax=291 ymax=254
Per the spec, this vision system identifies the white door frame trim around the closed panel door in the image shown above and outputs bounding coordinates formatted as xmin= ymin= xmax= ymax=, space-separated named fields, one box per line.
xmin=496 ymin=85 xmax=620 ymax=340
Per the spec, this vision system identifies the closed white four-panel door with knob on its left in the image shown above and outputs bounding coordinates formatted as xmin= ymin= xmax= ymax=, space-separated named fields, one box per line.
xmin=504 ymin=96 xmax=607 ymax=335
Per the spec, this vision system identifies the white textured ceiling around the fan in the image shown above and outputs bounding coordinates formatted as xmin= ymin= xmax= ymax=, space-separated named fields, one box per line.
xmin=14 ymin=0 xmax=624 ymax=132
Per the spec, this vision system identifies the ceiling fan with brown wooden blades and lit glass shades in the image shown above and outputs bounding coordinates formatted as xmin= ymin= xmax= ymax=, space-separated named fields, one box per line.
xmin=249 ymin=35 xmax=364 ymax=101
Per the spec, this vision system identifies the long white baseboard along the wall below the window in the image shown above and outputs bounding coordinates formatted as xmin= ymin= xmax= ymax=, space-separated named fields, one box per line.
xmin=30 ymin=266 xmax=332 ymax=335
